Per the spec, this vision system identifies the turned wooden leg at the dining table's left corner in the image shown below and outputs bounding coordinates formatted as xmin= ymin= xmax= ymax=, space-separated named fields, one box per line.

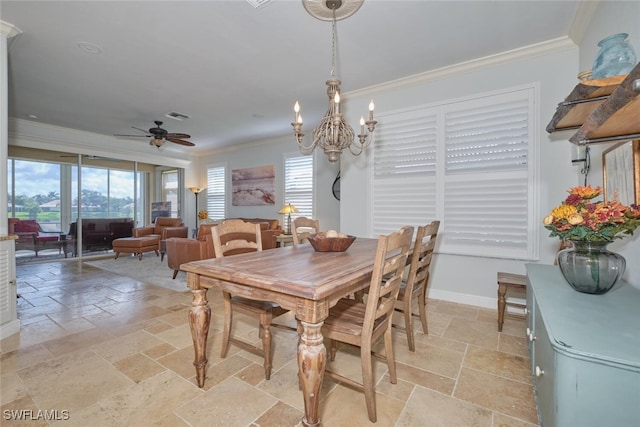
xmin=189 ymin=289 xmax=211 ymax=387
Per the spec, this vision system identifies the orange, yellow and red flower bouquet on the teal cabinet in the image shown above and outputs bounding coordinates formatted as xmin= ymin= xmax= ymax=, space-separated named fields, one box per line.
xmin=543 ymin=185 xmax=640 ymax=242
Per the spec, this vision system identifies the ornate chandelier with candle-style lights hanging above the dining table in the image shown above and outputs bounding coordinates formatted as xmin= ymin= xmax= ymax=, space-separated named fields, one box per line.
xmin=291 ymin=0 xmax=378 ymax=163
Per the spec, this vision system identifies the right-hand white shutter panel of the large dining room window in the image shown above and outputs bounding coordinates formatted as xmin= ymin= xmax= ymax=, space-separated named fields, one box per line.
xmin=442 ymin=91 xmax=531 ymax=258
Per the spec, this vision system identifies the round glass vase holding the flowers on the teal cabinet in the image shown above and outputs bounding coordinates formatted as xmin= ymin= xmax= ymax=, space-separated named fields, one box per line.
xmin=558 ymin=240 xmax=627 ymax=295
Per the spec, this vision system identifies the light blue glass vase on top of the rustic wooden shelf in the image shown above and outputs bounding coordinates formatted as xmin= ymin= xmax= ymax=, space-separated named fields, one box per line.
xmin=592 ymin=33 xmax=636 ymax=79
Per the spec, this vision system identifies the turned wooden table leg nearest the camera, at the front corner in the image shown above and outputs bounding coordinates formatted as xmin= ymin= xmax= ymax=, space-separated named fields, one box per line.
xmin=298 ymin=321 xmax=327 ymax=427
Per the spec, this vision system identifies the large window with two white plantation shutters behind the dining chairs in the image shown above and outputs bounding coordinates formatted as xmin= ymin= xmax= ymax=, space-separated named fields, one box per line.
xmin=372 ymin=87 xmax=537 ymax=259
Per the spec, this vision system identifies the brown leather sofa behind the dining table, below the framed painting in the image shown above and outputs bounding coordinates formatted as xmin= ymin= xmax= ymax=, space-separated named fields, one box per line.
xmin=165 ymin=218 xmax=282 ymax=279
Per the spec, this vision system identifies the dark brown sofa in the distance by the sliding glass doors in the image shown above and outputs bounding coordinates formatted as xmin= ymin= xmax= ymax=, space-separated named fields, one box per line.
xmin=67 ymin=218 xmax=134 ymax=251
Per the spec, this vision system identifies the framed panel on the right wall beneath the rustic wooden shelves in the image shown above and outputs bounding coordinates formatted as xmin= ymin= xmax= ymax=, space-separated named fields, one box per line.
xmin=602 ymin=140 xmax=640 ymax=205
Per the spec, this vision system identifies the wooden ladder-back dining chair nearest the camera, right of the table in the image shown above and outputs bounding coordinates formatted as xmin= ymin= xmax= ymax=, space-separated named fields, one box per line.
xmin=322 ymin=226 xmax=413 ymax=422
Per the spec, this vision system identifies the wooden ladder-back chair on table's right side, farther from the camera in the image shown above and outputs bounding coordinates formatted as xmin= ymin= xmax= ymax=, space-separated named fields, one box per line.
xmin=393 ymin=221 xmax=440 ymax=351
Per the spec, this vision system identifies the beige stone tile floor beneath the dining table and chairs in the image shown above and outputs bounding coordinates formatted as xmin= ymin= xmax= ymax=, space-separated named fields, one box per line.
xmin=0 ymin=260 xmax=538 ymax=427
